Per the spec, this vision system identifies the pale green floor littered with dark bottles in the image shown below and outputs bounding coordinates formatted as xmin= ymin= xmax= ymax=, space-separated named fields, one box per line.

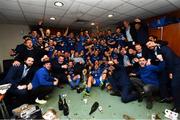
xmin=40 ymin=86 xmax=172 ymax=120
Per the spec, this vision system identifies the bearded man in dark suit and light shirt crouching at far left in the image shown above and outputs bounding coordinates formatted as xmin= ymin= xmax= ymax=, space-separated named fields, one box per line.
xmin=2 ymin=57 xmax=35 ymax=112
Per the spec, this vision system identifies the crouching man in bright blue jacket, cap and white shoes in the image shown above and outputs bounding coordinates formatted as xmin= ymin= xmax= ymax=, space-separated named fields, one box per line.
xmin=28 ymin=61 xmax=58 ymax=104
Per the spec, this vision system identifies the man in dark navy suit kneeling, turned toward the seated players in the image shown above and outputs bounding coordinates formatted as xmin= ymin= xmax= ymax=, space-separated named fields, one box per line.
xmin=108 ymin=59 xmax=138 ymax=103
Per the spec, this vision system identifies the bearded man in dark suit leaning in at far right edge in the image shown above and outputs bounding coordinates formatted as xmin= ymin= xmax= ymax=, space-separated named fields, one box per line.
xmin=146 ymin=41 xmax=180 ymax=112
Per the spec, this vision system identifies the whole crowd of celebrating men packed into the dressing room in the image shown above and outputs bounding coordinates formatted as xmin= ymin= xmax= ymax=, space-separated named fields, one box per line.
xmin=1 ymin=19 xmax=180 ymax=115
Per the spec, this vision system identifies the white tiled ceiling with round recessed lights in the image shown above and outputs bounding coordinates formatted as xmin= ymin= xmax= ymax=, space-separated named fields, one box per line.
xmin=0 ymin=0 xmax=180 ymax=28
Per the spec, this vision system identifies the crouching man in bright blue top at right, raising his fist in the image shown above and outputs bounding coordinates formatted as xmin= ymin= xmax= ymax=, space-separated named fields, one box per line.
xmin=131 ymin=55 xmax=165 ymax=109
